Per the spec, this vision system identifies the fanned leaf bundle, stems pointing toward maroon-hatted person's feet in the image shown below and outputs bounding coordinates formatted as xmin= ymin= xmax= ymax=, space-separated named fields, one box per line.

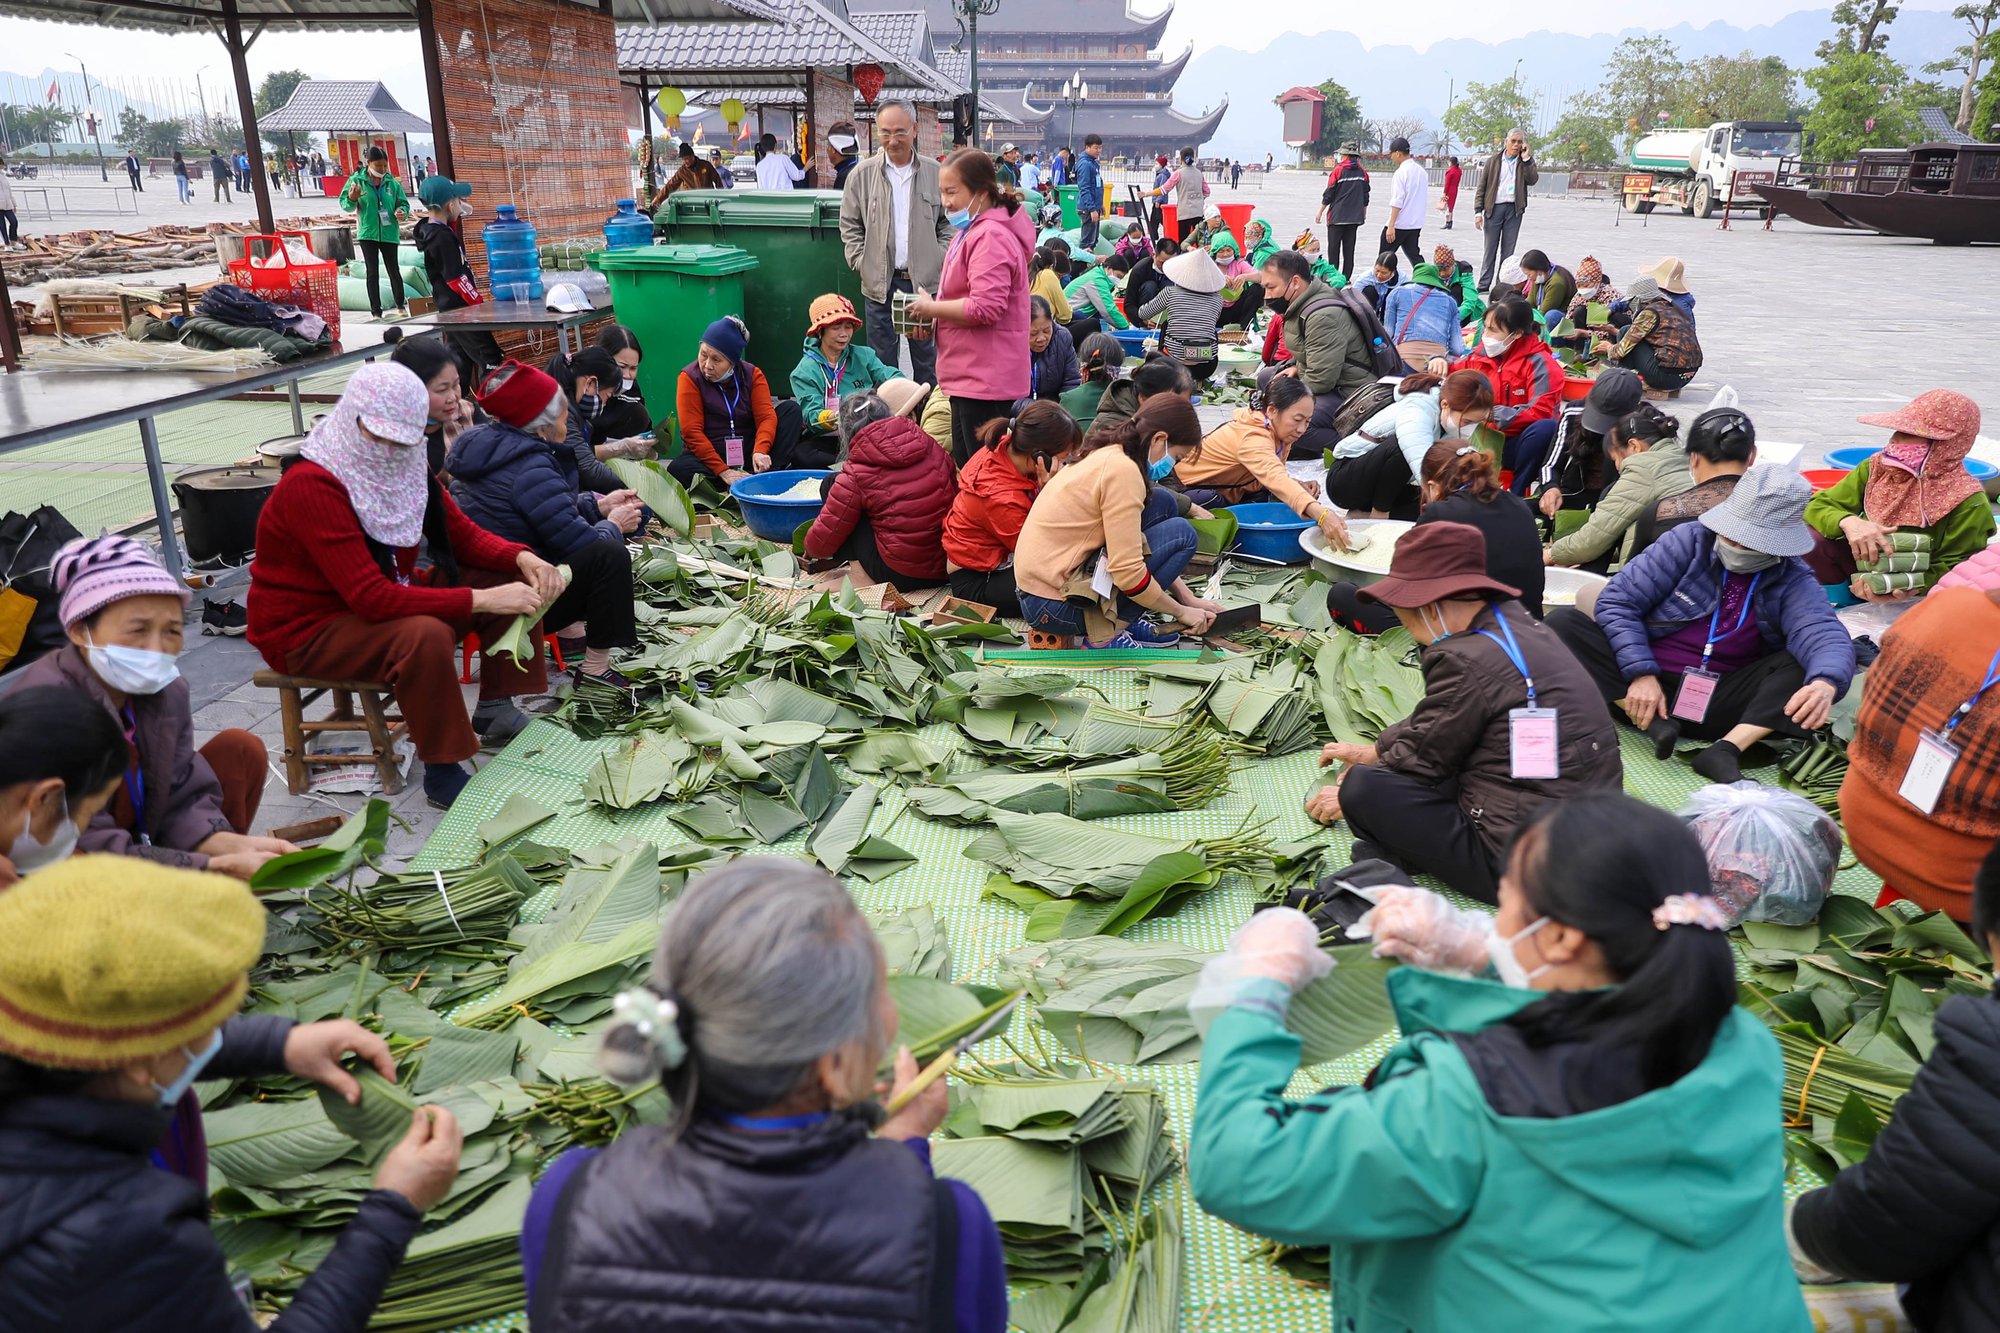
xmin=966 ymin=811 xmax=1278 ymax=941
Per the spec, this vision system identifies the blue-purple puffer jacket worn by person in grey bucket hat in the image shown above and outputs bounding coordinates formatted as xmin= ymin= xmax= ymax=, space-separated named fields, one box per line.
xmin=1596 ymin=522 xmax=1854 ymax=699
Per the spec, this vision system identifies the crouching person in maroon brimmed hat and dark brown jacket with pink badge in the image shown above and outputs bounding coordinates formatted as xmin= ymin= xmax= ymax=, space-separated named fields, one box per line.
xmin=1306 ymin=522 xmax=1624 ymax=903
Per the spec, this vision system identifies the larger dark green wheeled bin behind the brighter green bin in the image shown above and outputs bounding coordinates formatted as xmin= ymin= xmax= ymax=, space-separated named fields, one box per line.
xmin=654 ymin=190 xmax=862 ymax=352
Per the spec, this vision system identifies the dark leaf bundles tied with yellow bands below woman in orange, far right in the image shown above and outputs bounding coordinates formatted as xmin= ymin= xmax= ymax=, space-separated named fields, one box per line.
xmin=1740 ymin=895 xmax=1992 ymax=1177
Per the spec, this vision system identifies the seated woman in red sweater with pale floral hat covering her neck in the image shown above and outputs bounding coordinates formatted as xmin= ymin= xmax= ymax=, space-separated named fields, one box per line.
xmin=250 ymin=362 xmax=562 ymax=809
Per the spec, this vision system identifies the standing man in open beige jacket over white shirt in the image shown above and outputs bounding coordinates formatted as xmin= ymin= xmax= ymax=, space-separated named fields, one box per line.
xmin=840 ymin=102 xmax=952 ymax=384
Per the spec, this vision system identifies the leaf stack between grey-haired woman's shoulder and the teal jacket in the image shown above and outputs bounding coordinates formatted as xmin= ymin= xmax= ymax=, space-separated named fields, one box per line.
xmin=932 ymin=1063 xmax=1176 ymax=1283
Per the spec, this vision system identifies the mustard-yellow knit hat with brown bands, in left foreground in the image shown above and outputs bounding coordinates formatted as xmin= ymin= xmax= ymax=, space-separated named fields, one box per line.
xmin=0 ymin=857 xmax=264 ymax=1069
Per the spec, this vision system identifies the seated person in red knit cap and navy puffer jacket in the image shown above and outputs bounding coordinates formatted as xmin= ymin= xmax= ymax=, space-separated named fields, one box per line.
xmin=444 ymin=360 xmax=640 ymax=685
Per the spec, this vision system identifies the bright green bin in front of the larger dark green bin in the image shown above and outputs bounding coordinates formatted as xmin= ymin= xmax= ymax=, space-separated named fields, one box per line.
xmin=584 ymin=244 xmax=760 ymax=454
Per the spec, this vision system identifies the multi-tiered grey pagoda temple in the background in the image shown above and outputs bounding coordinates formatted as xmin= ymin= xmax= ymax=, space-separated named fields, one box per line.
xmin=852 ymin=0 xmax=1230 ymax=158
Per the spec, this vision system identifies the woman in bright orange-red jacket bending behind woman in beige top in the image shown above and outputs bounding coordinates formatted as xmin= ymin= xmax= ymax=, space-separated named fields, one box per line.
xmin=944 ymin=400 xmax=1084 ymax=616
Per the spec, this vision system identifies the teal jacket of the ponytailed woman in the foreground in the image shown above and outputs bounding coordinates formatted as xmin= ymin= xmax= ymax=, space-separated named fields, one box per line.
xmin=1188 ymin=967 xmax=1812 ymax=1333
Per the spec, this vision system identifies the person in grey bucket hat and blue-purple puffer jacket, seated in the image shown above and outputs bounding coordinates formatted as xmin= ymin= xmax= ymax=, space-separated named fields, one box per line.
xmin=1548 ymin=462 xmax=1854 ymax=783
